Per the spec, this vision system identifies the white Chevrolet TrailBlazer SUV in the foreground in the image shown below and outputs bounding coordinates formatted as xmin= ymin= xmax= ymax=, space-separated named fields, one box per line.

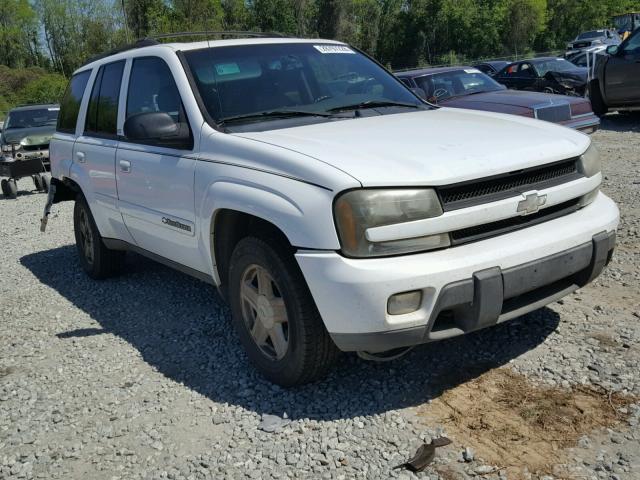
xmin=43 ymin=36 xmax=618 ymax=385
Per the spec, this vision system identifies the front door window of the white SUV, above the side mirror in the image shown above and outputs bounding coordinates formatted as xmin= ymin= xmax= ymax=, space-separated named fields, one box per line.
xmin=126 ymin=57 xmax=186 ymax=122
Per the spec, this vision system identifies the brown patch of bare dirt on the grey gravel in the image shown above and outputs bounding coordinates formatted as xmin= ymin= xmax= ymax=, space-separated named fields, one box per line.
xmin=418 ymin=368 xmax=637 ymax=479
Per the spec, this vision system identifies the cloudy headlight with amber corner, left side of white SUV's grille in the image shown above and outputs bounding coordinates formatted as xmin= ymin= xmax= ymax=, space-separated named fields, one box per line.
xmin=334 ymin=189 xmax=450 ymax=257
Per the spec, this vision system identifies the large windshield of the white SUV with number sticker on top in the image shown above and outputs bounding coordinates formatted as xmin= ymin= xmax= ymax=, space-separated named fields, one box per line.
xmin=185 ymin=43 xmax=424 ymax=127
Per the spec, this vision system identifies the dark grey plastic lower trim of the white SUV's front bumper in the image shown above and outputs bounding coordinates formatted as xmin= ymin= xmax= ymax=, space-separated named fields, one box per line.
xmin=331 ymin=232 xmax=615 ymax=353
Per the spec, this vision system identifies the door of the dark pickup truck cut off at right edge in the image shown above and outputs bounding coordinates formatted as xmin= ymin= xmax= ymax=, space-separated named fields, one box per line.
xmin=605 ymin=30 xmax=640 ymax=106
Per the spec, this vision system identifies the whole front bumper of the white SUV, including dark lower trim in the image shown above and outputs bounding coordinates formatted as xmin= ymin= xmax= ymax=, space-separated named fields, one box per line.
xmin=296 ymin=193 xmax=619 ymax=352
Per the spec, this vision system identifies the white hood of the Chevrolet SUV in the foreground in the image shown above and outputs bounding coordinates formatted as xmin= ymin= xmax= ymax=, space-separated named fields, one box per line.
xmin=233 ymin=108 xmax=590 ymax=187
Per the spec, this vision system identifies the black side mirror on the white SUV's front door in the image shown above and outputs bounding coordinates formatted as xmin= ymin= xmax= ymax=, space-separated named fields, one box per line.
xmin=124 ymin=112 xmax=193 ymax=148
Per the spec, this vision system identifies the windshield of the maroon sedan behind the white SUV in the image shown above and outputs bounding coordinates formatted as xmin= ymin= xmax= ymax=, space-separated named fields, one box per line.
xmin=415 ymin=68 xmax=504 ymax=103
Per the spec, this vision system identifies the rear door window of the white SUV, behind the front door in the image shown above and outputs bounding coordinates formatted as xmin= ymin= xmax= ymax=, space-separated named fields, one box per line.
xmin=85 ymin=60 xmax=124 ymax=137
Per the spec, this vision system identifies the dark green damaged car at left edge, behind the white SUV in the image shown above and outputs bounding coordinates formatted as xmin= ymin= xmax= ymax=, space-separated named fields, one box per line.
xmin=0 ymin=104 xmax=60 ymax=169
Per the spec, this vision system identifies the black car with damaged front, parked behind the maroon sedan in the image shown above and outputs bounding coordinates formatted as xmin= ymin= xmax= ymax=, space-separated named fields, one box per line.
xmin=493 ymin=57 xmax=588 ymax=97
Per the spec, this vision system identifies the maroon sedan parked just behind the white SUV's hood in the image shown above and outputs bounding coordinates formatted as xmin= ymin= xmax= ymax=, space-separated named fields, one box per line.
xmin=396 ymin=67 xmax=600 ymax=133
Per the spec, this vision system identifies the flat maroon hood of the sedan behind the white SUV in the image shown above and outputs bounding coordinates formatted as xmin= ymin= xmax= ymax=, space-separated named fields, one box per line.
xmin=441 ymin=90 xmax=585 ymax=111
